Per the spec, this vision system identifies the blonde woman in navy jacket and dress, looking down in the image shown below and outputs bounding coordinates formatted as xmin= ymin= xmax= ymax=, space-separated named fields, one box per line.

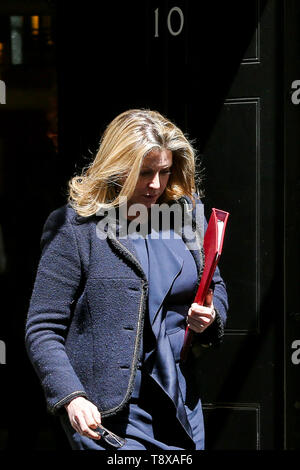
xmin=26 ymin=110 xmax=227 ymax=450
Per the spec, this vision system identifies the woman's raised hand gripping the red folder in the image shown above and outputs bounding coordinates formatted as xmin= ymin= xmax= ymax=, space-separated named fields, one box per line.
xmin=187 ymin=291 xmax=216 ymax=333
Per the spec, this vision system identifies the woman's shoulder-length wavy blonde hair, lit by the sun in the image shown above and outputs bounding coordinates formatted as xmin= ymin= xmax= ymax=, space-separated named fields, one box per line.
xmin=68 ymin=109 xmax=200 ymax=217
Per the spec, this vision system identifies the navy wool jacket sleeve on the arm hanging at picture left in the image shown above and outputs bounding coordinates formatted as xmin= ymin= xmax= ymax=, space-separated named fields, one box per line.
xmin=25 ymin=208 xmax=86 ymax=413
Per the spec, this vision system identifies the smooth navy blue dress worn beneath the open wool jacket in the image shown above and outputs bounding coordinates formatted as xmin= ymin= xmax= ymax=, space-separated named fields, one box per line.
xmin=62 ymin=226 xmax=204 ymax=450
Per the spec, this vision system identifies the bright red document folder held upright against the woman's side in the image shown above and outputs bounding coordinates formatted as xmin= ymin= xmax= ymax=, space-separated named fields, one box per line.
xmin=180 ymin=209 xmax=229 ymax=362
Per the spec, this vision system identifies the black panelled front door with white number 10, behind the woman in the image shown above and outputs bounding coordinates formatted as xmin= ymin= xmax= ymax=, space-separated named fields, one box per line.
xmin=54 ymin=0 xmax=298 ymax=450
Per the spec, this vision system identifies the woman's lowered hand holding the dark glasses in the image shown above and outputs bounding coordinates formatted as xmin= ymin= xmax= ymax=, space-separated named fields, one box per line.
xmin=65 ymin=397 xmax=101 ymax=440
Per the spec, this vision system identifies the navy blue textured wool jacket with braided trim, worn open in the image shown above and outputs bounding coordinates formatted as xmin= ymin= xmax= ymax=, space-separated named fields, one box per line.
xmin=26 ymin=198 xmax=227 ymax=416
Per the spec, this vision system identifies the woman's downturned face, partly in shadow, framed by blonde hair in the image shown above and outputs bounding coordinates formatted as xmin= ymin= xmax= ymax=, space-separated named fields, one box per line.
xmin=128 ymin=149 xmax=173 ymax=208
